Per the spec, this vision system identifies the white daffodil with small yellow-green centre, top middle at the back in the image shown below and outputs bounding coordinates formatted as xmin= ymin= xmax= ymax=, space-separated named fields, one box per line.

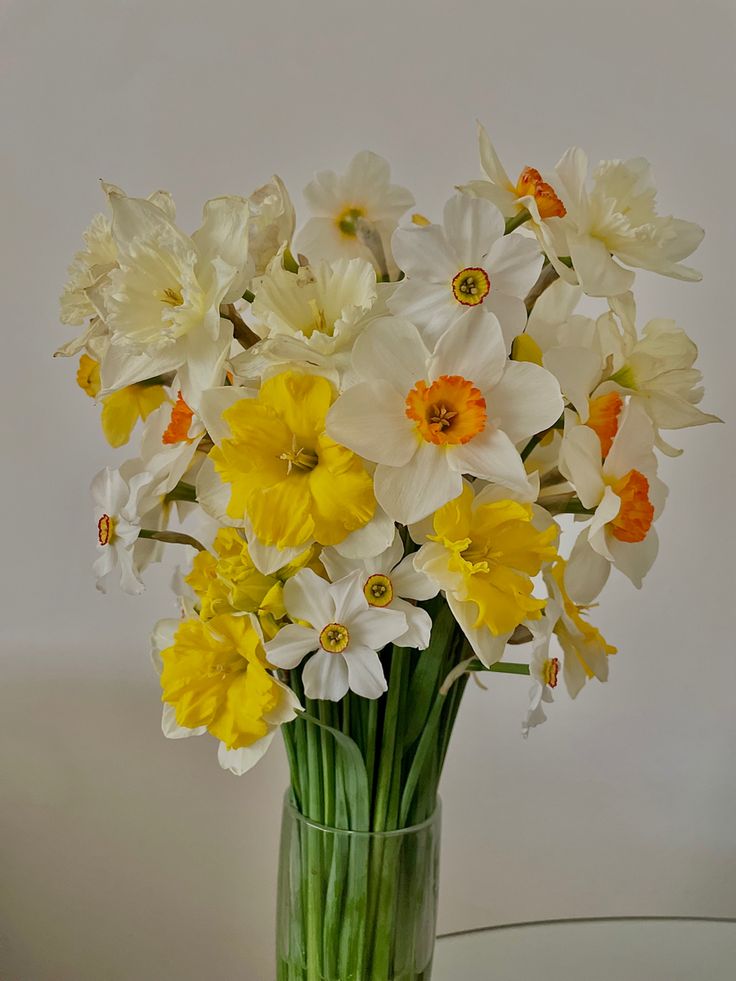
xmin=296 ymin=150 xmax=414 ymax=275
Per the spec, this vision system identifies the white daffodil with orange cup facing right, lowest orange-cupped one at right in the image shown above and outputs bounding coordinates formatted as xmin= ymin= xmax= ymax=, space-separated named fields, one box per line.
xmin=559 ymin=403 xmax=667 ymax=603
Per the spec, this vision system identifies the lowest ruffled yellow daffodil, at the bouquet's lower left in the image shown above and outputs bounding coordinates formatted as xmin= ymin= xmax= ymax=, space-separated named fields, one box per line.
xmin=160 ymin=614 xmax=298 ymax=750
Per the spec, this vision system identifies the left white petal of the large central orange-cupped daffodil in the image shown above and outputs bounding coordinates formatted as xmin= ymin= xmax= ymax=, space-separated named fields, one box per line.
xmin=325 ymin=381 xmax=417 ymax=467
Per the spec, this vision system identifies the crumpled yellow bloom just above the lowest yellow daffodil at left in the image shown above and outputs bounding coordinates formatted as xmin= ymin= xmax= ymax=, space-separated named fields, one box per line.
xmin=186 ymin=528 xmax=317 ymax=638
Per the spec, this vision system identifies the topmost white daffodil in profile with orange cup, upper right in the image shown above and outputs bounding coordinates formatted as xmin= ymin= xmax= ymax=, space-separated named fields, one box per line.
xmin=460 ymin=124 xmax=569 ymax=284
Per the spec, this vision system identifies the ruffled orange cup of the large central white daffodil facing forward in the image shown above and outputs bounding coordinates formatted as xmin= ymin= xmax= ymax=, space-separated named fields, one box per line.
xmin=406 ymin=375 xmax=487 ymax=446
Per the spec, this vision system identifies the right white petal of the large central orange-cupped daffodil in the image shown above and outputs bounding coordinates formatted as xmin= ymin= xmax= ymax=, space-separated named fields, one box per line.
xmin=487 ymin=361 xmax=564 ymax=443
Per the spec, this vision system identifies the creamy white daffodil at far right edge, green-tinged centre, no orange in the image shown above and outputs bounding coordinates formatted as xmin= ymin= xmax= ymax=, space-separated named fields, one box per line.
xmin=598 ymin=293 xmax=723 ymax=456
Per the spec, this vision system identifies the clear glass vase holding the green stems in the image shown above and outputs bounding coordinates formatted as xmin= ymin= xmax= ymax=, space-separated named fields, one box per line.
xmin=276 ymin=794 xmax=440 ymax=981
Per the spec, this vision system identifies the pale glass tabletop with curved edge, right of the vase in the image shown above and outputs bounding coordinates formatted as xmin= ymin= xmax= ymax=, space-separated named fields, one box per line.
xmin=432 ymin=917 xmax=736 ymax=981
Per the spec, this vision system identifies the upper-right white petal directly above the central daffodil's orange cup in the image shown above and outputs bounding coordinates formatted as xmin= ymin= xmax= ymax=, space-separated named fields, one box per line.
xmin=429 ymin=311 xmax=506 ymax=392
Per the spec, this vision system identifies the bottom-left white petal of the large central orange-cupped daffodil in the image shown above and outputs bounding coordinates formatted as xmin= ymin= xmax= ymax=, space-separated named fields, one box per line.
xmin=373 ymin=442 xmax=462 ymax=524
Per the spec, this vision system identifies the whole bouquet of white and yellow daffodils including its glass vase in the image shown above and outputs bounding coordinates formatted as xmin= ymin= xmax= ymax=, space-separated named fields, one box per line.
xmin=57 ymin=128 xmax=718 ymax=981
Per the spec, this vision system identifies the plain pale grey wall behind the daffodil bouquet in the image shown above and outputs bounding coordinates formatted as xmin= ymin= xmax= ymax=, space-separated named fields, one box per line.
xmin=0 ymin=0 xmax=736 ymax=981
